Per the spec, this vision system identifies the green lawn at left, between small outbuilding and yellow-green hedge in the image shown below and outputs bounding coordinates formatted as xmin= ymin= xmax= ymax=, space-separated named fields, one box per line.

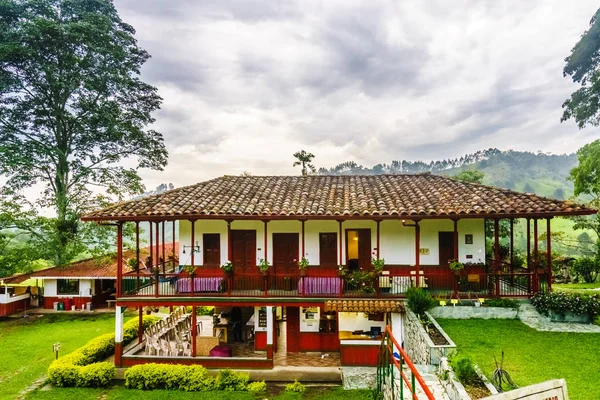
xmin=0 ymin=313 xmax=115 ymax=399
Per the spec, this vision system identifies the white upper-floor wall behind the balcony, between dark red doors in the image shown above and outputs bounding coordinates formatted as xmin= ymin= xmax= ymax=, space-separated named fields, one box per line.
xmin=179 ymin=219 xmax=485 ymax=265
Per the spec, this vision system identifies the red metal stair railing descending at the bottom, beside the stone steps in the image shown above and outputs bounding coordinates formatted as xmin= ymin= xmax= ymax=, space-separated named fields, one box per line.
xmin=377 ymin=326 xmax=435 ymax=400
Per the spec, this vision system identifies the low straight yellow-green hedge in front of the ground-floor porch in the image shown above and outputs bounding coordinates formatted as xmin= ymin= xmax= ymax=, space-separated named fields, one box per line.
xmin=125 ymin=363 xmax=249 ymax=392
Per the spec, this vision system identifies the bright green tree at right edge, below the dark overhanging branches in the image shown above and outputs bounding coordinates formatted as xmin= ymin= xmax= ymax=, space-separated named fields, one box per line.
xmin=567 ymin=139 xmax=600 ymax=256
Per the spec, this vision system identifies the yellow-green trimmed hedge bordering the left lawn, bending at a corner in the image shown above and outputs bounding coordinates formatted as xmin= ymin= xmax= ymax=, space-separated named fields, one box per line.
xmin=48 ymin=315 xmax=160 ymax=387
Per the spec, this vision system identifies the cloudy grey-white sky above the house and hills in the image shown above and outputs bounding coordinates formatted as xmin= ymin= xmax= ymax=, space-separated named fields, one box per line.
xmin=114 ymin=0 xmax=600 ymax=187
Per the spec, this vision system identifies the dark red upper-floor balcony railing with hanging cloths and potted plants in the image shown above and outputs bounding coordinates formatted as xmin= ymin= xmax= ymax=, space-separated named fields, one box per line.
xmin=119 ymin=267 xmax=546 ymax=299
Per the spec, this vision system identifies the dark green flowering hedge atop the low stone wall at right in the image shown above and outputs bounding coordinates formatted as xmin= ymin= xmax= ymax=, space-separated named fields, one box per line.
xmin=531 ymin=292 xmax=600 ymax=320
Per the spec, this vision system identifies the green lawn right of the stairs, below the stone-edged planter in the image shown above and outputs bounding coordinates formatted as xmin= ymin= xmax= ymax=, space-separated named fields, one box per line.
xmin=438 ymin=319 xmax=600 ymax=400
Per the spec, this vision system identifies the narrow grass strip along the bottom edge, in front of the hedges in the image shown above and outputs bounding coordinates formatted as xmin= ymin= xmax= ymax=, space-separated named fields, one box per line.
xmin=27 ymin=385 xmax=372 ymax=400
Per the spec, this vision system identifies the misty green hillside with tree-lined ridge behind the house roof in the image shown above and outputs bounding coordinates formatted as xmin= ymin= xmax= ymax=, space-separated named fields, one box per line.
xmin=318 ymin=149 xmax=577 ymax=199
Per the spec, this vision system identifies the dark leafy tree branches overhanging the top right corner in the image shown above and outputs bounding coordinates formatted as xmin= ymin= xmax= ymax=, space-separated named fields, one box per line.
xmin=561 ymin=10 xmax=600 ymax=128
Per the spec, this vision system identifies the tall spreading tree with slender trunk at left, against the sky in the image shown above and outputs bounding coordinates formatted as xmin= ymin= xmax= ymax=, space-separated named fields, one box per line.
xmin=0 ymin=0 xmax=167 ymax=264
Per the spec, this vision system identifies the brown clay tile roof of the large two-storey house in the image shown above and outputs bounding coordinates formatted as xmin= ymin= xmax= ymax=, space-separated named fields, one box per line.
xmin=83 ymin=174 xmax=596 ymax=220
